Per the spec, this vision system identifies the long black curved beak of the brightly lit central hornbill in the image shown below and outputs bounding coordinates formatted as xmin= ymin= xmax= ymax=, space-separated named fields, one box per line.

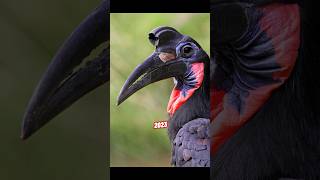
xmin=118 ymin=53 xmax=187 ymax=105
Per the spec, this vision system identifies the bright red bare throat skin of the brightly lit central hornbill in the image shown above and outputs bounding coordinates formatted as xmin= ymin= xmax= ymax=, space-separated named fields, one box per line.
xmin=167 ymin=63 xmax=204 ymax=116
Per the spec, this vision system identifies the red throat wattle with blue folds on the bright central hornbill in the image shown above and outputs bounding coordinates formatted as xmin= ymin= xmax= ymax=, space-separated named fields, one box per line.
xmin=167 ymin=62 xmax=204 ymax=116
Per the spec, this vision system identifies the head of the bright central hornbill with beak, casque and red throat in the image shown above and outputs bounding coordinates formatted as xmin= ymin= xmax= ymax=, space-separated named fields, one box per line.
xmin=118 ymin=27 xmax=209 ymax=115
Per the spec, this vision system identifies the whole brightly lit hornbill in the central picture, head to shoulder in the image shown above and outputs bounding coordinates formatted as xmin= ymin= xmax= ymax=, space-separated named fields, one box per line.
xmin=118 ymin=26 xmax=210 ymax=167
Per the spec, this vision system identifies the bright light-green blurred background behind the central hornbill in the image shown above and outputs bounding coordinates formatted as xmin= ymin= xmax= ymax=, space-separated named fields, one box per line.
xmin=110 ymin=13 xmax=210 ymax=166
